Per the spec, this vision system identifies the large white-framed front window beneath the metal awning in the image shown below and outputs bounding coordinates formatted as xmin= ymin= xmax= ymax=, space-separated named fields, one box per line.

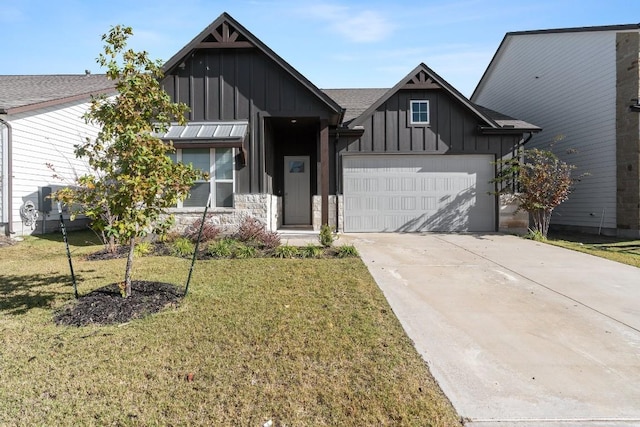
xmin=169 ymin=148 xmax=234 ymax=208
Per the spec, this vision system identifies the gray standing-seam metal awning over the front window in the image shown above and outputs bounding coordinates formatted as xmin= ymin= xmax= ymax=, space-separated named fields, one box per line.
xmin=159 ymin=120 xmax=249 ymax=148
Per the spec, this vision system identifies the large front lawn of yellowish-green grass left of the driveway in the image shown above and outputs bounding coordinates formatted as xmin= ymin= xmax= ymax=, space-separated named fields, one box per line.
xmin=0 ymin=233 xmax=460 ymax=426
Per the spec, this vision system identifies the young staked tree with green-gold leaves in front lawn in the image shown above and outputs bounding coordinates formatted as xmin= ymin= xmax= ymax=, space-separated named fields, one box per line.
xmin=57 ymin=25 xmax=203 ymax=296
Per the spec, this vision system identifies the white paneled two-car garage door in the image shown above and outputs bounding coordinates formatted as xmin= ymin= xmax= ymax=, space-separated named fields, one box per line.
xmin=343 ymin=154 xmax=495 ymax=232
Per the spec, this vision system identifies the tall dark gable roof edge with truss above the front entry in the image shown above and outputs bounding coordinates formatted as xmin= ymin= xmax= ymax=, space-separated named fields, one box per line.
xmin=162 ymin=12 xmax=343 ymax=123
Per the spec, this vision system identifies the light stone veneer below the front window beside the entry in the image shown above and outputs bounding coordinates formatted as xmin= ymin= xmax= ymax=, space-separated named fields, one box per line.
xmin=174 ymin=194 xmax=282 ymax=233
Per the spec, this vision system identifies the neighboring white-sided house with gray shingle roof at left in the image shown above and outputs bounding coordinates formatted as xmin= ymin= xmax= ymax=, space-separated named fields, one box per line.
xmin=0 ymin=74 xmax=115 ymax=235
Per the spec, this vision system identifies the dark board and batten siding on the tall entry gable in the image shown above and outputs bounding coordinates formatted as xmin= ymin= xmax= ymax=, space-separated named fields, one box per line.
xmin=162 ymin=48 xmax=338 ymax=193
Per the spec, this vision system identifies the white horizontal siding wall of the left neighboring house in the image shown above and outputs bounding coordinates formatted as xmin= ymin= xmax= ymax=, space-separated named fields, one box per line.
xmin=11 ymin=102 xmax=98 ymax=234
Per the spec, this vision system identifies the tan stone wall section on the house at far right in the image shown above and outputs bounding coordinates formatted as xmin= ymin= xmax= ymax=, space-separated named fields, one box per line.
xmin=616 ymin=32 xmax=640 ymax=238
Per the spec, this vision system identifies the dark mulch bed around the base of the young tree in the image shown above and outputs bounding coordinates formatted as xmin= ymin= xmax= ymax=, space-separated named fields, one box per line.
xmin=54 ymin=280 xmax=182 ymax=326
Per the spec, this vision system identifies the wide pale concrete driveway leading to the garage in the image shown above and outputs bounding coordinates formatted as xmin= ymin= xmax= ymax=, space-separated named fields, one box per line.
xmin=345 ymin=234 xmax=640 ymax=427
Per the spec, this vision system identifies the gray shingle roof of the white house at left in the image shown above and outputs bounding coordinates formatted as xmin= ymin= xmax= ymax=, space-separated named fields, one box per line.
xmin=0 ymin=74 xmax=115 ymax=114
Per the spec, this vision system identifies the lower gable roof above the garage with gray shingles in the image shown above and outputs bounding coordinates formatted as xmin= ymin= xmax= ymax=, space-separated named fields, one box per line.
xmin=340 ymin=63 xmax=540 ymax=133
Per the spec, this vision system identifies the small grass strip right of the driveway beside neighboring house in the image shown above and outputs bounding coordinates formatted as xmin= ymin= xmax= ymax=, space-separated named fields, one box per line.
xmin=547 ymin=233 xmax=640 ymax=267
